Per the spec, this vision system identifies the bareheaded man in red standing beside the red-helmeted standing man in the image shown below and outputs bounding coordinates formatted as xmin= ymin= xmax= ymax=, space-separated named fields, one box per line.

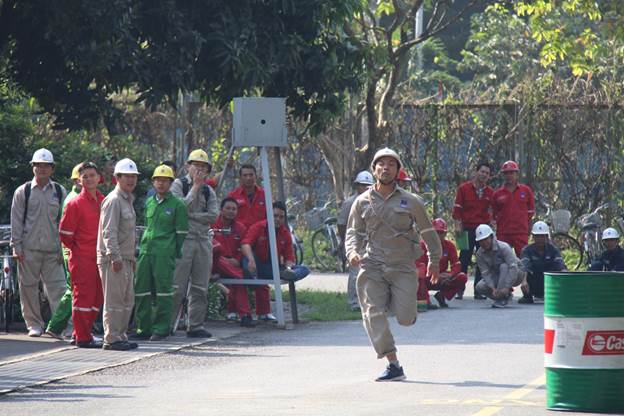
xmin=453 ymin=161 xmax=494 ymax=299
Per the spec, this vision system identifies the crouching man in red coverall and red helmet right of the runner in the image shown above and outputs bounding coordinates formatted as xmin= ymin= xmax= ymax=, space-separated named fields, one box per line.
xmin=416 ymin=218 xmax=468 ymax=308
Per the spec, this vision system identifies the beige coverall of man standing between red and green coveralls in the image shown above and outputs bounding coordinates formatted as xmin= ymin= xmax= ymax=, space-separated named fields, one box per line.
xmin=97 ymin=185 xmax=136 ymax=344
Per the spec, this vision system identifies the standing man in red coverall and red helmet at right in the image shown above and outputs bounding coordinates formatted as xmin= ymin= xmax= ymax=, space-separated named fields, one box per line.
xmin=492 ymin=160 xmax=535 ymax=257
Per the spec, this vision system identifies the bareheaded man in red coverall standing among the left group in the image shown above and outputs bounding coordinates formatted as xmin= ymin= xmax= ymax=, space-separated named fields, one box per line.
xmin=59 ymin=162 xmax=104 ymax=348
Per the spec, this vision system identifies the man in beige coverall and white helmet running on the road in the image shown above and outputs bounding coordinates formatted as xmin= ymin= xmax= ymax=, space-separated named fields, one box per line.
xmin=345 ymin=148 xmax=442 ymax=381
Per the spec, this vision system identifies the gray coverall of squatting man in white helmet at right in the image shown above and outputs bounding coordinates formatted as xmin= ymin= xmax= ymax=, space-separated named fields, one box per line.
xmin=475 ymin=238 xmax=526 ymax=298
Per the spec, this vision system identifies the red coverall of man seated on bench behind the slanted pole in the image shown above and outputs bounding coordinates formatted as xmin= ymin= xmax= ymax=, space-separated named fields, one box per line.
xmin=242 ymin=220 xmax=295 ymax=315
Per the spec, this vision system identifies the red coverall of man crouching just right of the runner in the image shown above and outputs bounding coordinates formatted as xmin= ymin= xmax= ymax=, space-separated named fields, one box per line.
xmin=416 ymin=239 xmax=468 ymax=303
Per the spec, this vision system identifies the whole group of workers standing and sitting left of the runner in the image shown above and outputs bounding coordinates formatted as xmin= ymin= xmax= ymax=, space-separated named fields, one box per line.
xmin=11 ymin=149 xmax=309 ymax=351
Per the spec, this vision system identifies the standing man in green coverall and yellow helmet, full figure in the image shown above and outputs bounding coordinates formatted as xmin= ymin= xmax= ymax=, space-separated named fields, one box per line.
xmin=133 ymin=165 xmax=188 ymax=341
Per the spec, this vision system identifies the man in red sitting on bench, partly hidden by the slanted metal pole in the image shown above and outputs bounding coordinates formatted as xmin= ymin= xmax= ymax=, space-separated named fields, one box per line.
xmin=241 ymin=201 xmax=310 ymax=322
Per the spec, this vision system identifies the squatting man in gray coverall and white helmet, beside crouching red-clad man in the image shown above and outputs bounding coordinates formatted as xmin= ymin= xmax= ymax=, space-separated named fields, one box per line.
xmin=475 ymin=224 xmax=526 ymax=308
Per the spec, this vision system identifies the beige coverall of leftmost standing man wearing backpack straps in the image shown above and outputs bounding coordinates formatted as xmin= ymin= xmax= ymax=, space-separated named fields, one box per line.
xmin=11 ymin=178 xmax=67 ymax=331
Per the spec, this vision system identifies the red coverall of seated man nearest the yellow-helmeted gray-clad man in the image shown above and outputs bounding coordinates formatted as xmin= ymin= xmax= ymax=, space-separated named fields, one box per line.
xmin=212 ymin=215 xmax=260 ymax=316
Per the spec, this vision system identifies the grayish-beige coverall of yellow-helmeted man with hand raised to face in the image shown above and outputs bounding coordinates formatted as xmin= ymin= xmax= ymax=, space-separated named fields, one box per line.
xmin=171 ymin=176 xmax=219 ymax=331
